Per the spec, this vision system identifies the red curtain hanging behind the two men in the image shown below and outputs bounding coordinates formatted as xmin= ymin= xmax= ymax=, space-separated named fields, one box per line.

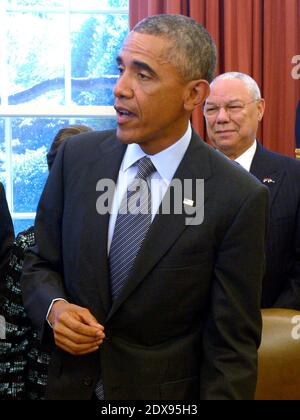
xmin=129 ymin=0 xmax=300 ymax=156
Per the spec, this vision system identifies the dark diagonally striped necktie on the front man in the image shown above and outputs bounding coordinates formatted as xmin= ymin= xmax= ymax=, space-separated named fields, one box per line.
xmin=109 ymin=157 xmax=156 ymax=300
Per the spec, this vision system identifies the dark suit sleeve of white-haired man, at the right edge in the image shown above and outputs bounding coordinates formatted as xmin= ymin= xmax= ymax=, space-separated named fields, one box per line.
xmin=273 ymin=202 xmax=300 ymax=311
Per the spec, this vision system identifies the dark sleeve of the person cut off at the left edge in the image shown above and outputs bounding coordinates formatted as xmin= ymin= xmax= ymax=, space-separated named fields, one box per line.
xmin=0 ymin=183 xmax=14 ymax=270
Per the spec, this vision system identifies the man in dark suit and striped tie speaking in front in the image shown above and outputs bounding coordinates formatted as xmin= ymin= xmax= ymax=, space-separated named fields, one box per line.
xmin=23 ymin=15 xmax=268 ymax=400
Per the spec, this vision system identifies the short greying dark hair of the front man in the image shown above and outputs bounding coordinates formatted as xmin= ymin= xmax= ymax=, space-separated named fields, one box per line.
xmin=133 ymin=14 xmax=217 ymax=83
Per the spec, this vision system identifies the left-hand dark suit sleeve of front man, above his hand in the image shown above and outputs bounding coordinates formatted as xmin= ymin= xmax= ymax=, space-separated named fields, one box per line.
xmin=21 ymin=144 xmax=66 ymax=336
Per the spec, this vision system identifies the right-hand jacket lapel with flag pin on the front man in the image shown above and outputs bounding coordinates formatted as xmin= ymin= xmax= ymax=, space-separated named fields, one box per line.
xmin=107 ymin=134 xmax=211 ymax=320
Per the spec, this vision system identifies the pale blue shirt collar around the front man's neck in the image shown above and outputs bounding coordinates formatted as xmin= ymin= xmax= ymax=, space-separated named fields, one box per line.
xmin=121 ymin=123 xmax=192 ymax=183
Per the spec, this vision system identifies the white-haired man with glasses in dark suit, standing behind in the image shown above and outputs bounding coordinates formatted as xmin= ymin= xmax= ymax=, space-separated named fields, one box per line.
xmin=204 ymin=73 xmax=300 ymax=310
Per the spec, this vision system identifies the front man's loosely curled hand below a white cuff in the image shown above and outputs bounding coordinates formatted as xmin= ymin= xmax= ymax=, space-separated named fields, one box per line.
xmin=48 ymin=300 xmax=105 ymax=356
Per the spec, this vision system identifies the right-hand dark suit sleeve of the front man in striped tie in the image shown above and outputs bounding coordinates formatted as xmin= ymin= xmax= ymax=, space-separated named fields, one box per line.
xmin=201 ymin=186 xmax=268 ymax=400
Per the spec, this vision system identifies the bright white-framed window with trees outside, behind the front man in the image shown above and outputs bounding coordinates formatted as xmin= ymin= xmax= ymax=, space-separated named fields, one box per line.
xmin=0 ymin=0 xmax=129 ymax=232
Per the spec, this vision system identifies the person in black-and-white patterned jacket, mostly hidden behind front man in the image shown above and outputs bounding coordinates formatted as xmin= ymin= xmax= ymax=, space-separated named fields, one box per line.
xmin=0 ymin=125 xmax=92 ymax=400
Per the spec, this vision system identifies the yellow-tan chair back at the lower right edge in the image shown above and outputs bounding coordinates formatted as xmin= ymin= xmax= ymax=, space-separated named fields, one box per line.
xmin=256 ymin=309 xmax=300 ymax=400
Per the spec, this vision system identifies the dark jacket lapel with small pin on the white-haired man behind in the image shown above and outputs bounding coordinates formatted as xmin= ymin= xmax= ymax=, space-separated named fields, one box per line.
xmin=250 ymin=143 xmax=286 ymax=207
